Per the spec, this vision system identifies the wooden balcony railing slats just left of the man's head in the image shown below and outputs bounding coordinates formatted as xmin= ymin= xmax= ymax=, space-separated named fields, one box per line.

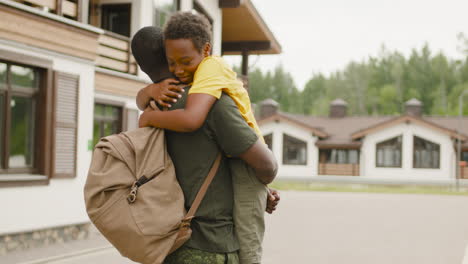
xmin=96 ymin=32 xmax=137 ymax=74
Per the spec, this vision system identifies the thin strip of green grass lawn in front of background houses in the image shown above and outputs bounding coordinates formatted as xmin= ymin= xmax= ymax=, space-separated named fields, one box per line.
xmin=269 ymin=181 xmax=468 ymax=196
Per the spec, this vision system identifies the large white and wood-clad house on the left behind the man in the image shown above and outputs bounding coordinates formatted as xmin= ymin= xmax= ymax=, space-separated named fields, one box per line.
xmin=0 ymin=0 xmax=281 ymax=254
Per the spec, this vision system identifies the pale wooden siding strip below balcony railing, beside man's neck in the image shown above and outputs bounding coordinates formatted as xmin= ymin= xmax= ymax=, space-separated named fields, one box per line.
xmin=95 ymin=72 xmax=148 ymax=97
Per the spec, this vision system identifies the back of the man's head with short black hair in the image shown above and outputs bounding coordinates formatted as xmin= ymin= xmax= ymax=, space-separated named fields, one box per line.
xmin=132 ymin=27 xmax=173 ymax=83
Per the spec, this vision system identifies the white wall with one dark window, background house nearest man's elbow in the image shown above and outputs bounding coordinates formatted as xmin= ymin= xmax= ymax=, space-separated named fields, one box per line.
xmin=260 ymin=122 xmax=318 ymax=179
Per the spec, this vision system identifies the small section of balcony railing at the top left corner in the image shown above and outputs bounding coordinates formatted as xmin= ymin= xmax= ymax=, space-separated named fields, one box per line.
xmin=13 ymin=0 xmax=79 ymax=20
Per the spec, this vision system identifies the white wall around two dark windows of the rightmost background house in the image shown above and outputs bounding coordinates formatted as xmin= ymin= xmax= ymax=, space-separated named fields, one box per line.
xmin=360 ymin=123 xmax=455 ymax=179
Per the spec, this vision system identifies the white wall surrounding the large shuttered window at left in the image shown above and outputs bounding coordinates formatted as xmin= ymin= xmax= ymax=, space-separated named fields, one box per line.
xmin=0 ymin=42 xmax=94 ymax=234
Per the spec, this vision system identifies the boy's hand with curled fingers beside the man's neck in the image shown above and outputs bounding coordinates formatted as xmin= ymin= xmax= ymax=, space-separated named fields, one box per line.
xmin=146 ymin=78 xmax=184 ymax=107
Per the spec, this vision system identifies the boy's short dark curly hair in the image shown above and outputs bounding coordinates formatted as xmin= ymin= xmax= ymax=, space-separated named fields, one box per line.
xmin=164 ymin=12 xmax=211 ymax=51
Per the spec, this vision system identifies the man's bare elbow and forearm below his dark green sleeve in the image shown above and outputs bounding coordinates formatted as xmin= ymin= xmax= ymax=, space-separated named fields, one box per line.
xmin=239 ymin=139 xmax=278 ymax=184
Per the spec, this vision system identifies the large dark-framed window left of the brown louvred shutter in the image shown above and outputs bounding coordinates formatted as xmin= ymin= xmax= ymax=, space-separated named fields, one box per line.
xmin=0 ymin=62 xmax=44 ymax=173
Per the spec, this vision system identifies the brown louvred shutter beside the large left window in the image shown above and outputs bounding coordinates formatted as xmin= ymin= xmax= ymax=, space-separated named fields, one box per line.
xmin=51 ymin=72 xmax=79 ymax=178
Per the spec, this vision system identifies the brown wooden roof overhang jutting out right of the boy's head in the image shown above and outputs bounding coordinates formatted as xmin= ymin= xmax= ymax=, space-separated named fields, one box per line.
xmin=219 ymin=0 xmax=281 ymax=55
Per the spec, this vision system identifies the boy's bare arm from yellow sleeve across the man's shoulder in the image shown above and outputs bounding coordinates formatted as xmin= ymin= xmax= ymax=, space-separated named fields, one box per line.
xmin=139 ymin=94 xmax=216 ymax=132
